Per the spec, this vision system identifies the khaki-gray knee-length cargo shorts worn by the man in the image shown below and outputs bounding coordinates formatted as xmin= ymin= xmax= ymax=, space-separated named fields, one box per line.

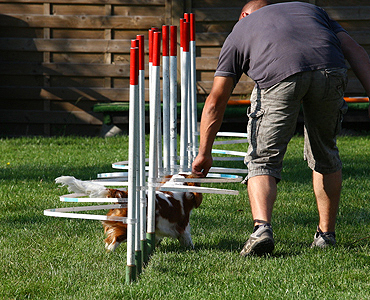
xmin=244 ymin=68 xmax=348 ymax=183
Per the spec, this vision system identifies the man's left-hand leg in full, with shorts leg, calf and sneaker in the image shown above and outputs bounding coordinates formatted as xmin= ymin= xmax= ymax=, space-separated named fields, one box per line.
xmin=240 ymin=73 xmax=309 ymax=256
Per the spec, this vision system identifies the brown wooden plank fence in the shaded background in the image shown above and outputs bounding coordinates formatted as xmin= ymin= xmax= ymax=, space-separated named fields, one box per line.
xmin=0 ymin=0 xmax=370 ymax=136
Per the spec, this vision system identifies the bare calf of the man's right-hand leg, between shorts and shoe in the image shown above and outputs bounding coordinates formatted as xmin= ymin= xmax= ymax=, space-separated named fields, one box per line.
xmin=312 ymin=170 xmax=342 ymax=232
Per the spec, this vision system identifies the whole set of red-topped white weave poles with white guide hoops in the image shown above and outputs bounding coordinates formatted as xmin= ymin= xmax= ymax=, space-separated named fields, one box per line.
xmin=44 ymin=14 xmax=246 ymax=283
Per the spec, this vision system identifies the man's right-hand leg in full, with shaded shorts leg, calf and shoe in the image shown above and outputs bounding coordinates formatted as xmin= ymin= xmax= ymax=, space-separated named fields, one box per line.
xmin=303 ymin=68 xmax=347 ymax=248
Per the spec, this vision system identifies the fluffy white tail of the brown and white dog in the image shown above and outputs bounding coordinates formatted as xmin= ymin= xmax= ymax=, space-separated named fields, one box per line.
xmin=55 ymin=176 xmax=109 ymax=198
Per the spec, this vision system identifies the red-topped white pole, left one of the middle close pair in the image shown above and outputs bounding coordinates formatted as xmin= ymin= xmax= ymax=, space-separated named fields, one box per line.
xmin=162 ymin=25 xmax=170 ymax=174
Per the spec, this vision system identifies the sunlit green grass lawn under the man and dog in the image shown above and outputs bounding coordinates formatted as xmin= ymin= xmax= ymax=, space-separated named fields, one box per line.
xmin=0 ymin=136 xmax=370 ymax=300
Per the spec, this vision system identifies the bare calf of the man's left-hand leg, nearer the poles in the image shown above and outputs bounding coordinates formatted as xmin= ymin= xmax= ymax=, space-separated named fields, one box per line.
xmin=248 ymin=175 xmax=277 ymax=225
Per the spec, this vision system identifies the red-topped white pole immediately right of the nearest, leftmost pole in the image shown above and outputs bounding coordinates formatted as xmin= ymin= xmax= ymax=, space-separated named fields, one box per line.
xmin=136 ymin=34 xmax=148 ymax=266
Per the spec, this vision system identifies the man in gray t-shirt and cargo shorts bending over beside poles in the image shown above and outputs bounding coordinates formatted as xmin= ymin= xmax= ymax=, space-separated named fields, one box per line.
xmin=192 ymin=0 xmax=370 ymax=256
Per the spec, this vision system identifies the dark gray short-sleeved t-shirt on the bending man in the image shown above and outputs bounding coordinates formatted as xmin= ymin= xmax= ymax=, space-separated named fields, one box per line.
xmin=215 ymin=2 xmax=346 ymax=88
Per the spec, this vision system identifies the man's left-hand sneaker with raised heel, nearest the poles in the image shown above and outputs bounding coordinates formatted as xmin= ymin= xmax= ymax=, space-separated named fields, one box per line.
xmin=240 ymin=224 xmax=274 ymax=256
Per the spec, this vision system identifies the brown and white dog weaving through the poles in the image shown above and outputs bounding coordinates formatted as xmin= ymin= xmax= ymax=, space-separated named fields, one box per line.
xmin=55 ymin=173 xmax=203 ymax=251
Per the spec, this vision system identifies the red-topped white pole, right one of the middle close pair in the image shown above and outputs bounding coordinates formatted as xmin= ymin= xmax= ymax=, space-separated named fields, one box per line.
xmin=170 ymin=26 xmax=177 ymax=174
